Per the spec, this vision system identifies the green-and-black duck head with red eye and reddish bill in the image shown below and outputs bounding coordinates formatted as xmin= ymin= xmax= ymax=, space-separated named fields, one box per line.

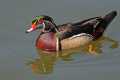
xmin=26 ymin=15 xmax=56 ymax=33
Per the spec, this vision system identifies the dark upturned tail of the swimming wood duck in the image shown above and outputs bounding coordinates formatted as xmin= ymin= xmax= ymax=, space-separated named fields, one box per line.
xmin=93 ymin=11 xmax=117 ymax=38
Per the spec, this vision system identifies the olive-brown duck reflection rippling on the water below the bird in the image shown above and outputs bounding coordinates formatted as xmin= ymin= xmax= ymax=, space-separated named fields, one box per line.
xmin=29 ymin=36 xmax=118 ymax=74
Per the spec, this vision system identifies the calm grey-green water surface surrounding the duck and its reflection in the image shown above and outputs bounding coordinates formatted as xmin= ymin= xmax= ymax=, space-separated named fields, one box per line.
xmin=0 ymin=0 xmax=120 ymax=80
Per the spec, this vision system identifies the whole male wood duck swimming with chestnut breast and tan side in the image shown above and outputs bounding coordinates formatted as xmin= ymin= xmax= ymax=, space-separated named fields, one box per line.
xmin=26 ymin=11 xmax=117 ymax=52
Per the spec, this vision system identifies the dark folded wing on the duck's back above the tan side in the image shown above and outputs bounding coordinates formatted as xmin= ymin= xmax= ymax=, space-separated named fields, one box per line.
xmin=58 ymin=17 xmax=97 ymax=39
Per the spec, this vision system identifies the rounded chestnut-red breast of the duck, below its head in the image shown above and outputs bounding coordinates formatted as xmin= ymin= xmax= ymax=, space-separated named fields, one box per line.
xmin=36 ymin=32 xmax=56 ymax=51
